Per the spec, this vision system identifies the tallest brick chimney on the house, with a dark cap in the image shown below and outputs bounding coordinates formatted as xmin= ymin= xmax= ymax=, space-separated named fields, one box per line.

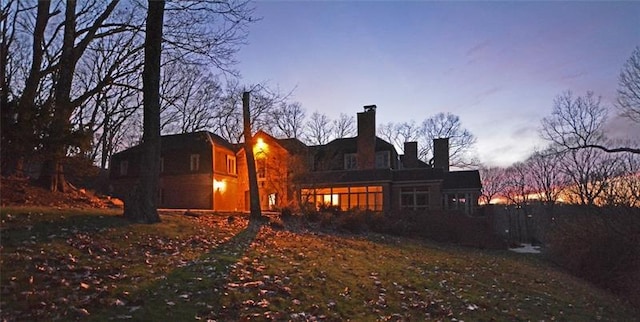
xmin=356 ymin=105 xmax=376 ymax=169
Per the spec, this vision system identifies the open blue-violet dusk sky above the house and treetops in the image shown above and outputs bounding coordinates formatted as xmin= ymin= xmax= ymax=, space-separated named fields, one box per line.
xmin=237 ymin=1 xmax=640 ymax=166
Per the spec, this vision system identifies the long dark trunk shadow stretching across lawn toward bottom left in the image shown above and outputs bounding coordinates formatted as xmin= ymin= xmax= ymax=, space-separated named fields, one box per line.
xmin=91 ymin=221 xmax=264 ymax=321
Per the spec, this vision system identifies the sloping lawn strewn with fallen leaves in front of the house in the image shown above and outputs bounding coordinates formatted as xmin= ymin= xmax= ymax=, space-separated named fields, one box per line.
xmin=0 ymin=208 xmax=638 ymax=321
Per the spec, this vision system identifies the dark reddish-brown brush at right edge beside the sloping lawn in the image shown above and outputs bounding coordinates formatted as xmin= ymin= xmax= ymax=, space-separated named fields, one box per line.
xmin=548 ymin=207 xmax=640 ymax=305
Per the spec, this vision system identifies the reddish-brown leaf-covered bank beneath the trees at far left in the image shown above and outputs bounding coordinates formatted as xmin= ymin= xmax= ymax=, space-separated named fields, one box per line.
xmin=0 ymin=177 xmax=122 ymax=208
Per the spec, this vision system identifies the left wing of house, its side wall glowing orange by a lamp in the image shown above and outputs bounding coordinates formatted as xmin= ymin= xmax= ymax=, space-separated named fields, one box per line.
xmin=109 ymin=131 xmax=240 ymax=211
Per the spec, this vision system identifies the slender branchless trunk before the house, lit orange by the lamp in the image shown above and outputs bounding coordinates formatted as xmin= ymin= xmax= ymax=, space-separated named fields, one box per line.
xmin=242 ymin=92 xmax=262 ymax=219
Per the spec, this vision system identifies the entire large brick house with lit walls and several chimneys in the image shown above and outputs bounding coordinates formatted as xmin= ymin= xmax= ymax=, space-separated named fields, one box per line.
xmin=110 ymin=105 xmax=481 ymax=214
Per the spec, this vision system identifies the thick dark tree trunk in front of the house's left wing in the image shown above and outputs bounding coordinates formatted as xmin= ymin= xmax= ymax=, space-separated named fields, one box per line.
xmin=124 ymin=0 xmax=164 ymax=224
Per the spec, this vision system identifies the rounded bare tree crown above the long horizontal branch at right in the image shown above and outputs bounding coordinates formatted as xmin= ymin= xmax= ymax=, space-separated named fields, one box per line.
xmin=540 ymin=91 xmax=640 ymax=154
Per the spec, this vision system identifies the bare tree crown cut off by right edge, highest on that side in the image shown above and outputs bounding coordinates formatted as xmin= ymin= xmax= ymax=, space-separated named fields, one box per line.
xmin=618 ymin=46 xmax=640 ymax=123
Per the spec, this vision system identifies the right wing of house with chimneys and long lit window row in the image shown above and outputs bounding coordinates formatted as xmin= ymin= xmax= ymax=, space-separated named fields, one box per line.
xmin=297 ymin=105 xmax=482 ymax=214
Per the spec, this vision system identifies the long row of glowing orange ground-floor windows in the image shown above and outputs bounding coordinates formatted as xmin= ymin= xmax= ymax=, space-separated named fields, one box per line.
xmin=300 ymin=186 xmax=383 ymax=211
